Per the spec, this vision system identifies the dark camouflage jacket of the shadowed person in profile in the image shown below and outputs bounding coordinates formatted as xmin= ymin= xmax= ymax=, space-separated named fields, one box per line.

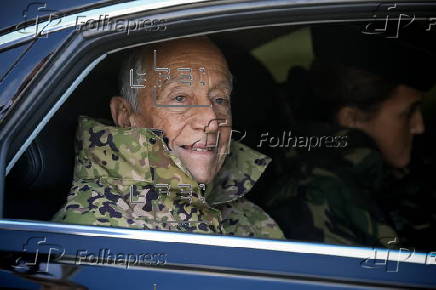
xmin=266 ymin=124 xmax=397 ymax=246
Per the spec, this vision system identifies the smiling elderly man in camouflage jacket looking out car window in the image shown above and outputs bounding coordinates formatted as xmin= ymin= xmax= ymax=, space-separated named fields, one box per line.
xmin=54 ymin=38 xmax=283 ymax=238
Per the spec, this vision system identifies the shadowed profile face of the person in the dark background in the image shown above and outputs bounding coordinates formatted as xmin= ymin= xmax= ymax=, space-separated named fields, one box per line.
xmin=356 ymin=85 xmax=425 ymax=168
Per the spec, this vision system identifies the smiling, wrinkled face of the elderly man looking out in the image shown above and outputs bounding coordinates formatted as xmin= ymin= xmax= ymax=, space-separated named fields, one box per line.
xmin=138 ymin=41 xmax=231 ymax=183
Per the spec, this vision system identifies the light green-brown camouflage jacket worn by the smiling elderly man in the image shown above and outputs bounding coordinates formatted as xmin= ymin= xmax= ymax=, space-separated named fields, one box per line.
xmin=53 ymin=117 xmax=283 ymax=239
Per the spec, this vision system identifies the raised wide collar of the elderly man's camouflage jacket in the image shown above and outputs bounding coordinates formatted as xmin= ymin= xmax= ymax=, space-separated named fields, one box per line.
xmin=74 ymin=116 xmax=271 ymax=205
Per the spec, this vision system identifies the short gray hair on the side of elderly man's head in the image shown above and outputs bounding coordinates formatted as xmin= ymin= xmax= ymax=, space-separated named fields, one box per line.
xmin=118 ymin=49 xmax=145 ymax=111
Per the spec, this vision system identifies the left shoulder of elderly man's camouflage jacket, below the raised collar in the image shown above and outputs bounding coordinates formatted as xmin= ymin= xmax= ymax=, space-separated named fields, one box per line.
xmin=52 ymin=180 xmax=145 ymax=229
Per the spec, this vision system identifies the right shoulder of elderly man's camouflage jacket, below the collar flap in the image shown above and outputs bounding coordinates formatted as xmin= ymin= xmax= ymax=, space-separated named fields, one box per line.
xmin=221 ymin=198 xmax=285 ymax=239
